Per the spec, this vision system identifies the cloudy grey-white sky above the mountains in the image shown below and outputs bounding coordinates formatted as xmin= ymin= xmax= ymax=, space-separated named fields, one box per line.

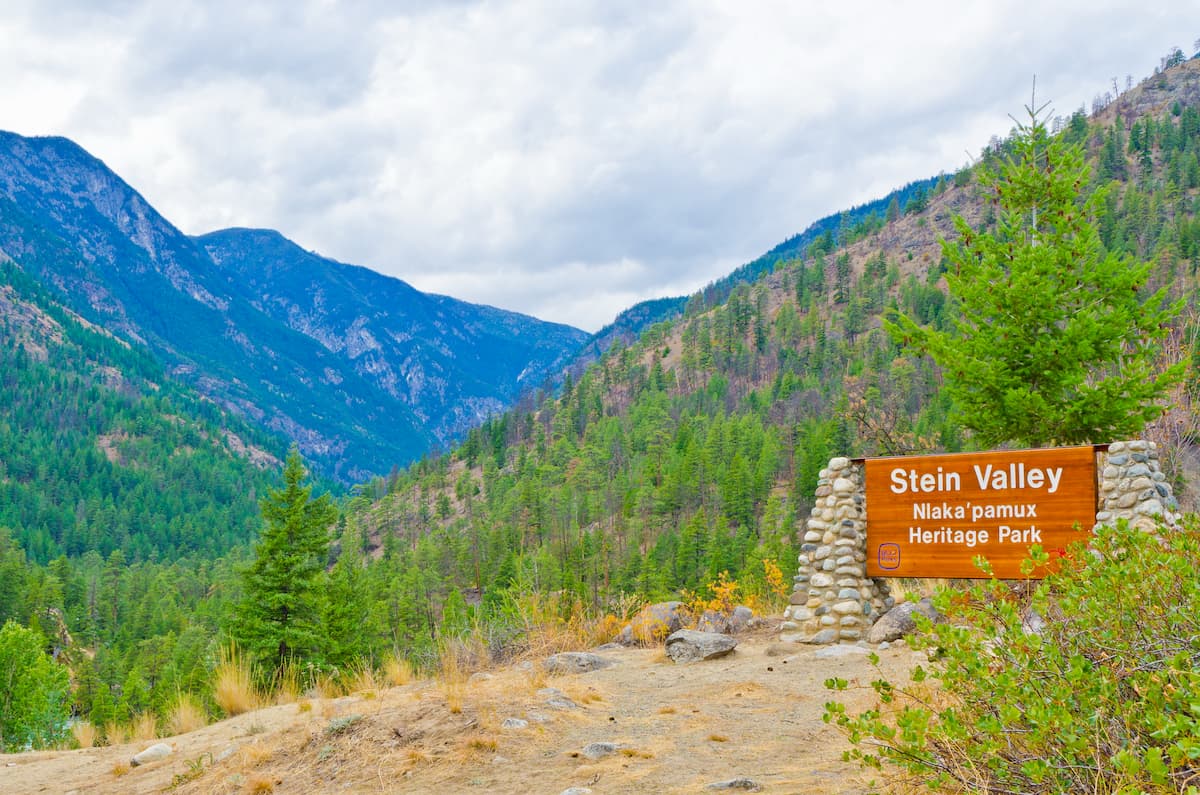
xmin=0 ymin=0 xmax=1200 ymax=330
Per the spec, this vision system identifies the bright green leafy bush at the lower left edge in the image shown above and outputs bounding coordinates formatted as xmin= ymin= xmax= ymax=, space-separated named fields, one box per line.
xmin=0 ymin=621 xmax=71 ymax=752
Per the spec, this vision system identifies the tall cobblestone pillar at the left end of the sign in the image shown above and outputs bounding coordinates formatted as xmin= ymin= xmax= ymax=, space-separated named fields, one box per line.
xmin=780 ymin=458 xmax=894 ymax=644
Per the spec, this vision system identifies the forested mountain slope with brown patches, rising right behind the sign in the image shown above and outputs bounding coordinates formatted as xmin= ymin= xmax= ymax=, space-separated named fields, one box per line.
xmin=333 ymin=52 xmax=1200 ymax=658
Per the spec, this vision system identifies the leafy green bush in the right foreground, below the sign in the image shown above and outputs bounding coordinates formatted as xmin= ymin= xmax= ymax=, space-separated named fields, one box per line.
xmin=824 ymin=516 xmax=1200 ymax=793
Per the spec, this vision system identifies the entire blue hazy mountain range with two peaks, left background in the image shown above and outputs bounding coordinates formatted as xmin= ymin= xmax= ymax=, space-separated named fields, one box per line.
xmin=0 ymin=132 xmax=587 ymax=482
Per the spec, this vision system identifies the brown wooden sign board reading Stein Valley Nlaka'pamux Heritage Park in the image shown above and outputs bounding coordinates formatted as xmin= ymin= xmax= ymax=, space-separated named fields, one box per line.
xmin=865 ymin=446 xmax=1096 ymax=579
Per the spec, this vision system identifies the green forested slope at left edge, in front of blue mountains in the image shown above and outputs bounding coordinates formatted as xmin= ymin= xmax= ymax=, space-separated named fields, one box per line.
xmin=0 ymin=262 xmax=284 ymax=564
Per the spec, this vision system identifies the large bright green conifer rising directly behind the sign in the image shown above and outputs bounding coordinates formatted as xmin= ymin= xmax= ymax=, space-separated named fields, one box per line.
xmin=888 ymin=102 xmax=1181 ymax=447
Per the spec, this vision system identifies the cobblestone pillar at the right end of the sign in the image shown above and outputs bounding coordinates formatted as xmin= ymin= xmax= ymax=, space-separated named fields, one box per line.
xmin=1096 ymin=440 xmax=1180 ymax=531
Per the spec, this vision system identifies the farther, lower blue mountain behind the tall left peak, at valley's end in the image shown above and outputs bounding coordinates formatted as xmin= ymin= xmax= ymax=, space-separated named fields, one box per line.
xmin=196 ymin=229 xmax=584 ymax=446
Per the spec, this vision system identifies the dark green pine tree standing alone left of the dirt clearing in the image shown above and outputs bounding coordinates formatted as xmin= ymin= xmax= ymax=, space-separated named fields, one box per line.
xmin=235 ymin=448 xmax=337 ymax=671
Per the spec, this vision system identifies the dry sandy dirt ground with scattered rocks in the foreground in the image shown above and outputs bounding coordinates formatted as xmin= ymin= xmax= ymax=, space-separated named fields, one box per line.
xmin=0 ymin=632 xmax=919 ymax=795
